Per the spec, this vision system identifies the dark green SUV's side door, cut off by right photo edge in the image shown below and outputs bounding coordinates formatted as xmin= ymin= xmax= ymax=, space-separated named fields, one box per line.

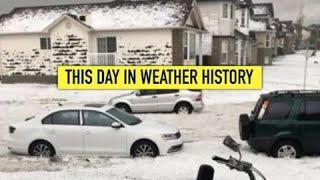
xmin=297 ymin=99 xmax=320 ymax=153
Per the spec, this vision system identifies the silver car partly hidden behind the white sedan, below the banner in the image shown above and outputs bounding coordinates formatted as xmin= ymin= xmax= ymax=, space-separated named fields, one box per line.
xmin=109 ymin=90 xmax=204 ymax=114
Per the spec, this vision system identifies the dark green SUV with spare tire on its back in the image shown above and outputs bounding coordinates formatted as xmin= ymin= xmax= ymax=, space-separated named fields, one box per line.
xmin=239 ymin=91 xmax=320 ymax=158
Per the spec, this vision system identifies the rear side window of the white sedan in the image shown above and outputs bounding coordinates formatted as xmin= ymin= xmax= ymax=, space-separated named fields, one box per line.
xmin=52 ymin=110 xmax=80 ymax=125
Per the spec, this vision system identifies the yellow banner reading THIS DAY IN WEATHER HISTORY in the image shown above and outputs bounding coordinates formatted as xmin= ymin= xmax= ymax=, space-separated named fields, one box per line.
xmin=58 ymin=66 xmax=263 ymax=90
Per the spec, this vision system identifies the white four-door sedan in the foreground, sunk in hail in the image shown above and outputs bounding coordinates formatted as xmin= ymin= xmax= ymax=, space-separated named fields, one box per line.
xmin=8 ymin=106 xmax=183 ymax=157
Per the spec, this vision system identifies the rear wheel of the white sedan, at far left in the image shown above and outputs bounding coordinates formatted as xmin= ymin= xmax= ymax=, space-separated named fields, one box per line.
xmin=29 ymin=141 xmax=55 ymax=157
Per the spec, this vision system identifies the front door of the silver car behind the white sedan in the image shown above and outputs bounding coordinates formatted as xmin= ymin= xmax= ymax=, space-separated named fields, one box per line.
xmin=130 ymin=90 xmax=158 ymax=112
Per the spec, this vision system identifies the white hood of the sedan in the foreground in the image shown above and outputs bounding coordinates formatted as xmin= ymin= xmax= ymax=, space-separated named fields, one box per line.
xmin=135 ymin=120 xmax=179 ymax=134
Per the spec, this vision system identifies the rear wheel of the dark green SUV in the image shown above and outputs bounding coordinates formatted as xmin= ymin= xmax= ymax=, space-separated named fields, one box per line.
xmin=272 ymin=141 xmax=302 ymax=159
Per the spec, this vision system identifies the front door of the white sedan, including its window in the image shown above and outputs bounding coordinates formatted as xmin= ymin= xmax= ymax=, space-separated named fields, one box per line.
xmin=82 ymin=110 xmax=127 ymax=155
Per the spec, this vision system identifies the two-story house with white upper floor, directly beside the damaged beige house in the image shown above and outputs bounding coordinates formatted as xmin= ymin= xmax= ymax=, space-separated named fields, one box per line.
xmin=198 ymin=0 xmax=237 ymax=65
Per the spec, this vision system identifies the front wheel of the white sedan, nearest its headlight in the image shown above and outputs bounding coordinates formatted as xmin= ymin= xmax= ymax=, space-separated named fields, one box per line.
xmin=132 ymin=141 xmax=158 ymax=158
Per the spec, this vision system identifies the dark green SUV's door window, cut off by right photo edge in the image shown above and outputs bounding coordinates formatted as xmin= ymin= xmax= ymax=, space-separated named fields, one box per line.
xmin=298 ymin=100 xmax=320 ymax=120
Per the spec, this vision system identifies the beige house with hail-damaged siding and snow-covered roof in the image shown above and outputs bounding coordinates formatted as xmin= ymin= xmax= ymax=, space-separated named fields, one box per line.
xmin=0 ymin=0 xmax=205 ymax=83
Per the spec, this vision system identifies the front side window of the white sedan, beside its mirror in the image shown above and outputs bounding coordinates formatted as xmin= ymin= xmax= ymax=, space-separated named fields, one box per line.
xmin=82 ymin=111 xmax=115 ymax=127
